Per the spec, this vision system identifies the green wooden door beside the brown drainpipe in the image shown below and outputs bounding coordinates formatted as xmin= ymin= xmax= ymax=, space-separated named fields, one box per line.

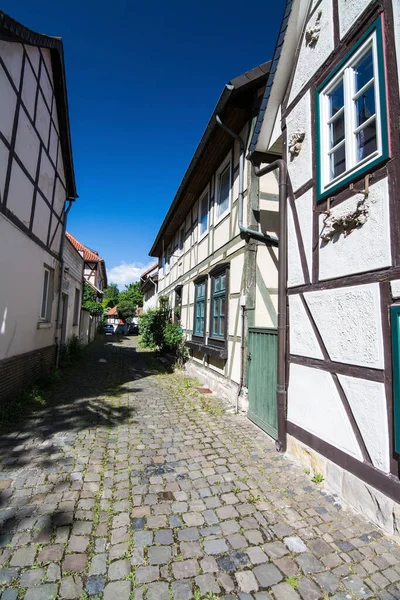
xmin=247 ymin=327 xmax=278 ymax=440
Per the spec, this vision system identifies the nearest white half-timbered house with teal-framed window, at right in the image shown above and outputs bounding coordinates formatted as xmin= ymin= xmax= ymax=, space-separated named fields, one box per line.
xmin=250 ymin=0 xmax=400 ymax=534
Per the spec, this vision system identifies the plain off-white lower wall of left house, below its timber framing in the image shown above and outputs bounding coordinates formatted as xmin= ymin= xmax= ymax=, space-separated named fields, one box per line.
xmin=0 ymin=214 xmax=58 ymax=360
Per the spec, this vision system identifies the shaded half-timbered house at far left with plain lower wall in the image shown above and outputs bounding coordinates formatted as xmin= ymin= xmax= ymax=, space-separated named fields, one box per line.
xmin=0 ymin=11 xmax=77 ymax=398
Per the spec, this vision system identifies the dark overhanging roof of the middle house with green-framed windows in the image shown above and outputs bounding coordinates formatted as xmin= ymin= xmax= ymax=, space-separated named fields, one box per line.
xmin=149 ymin=61 xmax=271 ymax=256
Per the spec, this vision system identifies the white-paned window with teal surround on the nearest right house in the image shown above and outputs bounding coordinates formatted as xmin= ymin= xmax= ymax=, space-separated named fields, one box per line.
xmin=316 ymin=19 xmax=388 ymax=199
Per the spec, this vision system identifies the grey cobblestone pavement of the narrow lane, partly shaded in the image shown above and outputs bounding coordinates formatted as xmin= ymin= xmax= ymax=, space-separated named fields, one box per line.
xmin=0 ymin=339 xmax=400 ymax=600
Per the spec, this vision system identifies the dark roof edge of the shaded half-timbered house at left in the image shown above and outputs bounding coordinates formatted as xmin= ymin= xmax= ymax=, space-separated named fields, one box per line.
xmin=0 ymin=10 xmax=78 ymax=200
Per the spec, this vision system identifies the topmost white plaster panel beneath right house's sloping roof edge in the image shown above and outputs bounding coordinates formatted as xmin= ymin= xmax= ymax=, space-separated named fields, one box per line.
xmin=289 ymin=0 xmax=334 ymax=103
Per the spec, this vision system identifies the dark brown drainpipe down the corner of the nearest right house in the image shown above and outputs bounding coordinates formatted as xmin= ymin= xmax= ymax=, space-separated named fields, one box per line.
xmin=254 ymin=159 xmax=288 ymax=452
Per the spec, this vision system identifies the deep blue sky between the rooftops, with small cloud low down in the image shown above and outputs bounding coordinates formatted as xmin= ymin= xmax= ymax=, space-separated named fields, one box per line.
xmin=2 ymin=0 xmax=285 ymax=284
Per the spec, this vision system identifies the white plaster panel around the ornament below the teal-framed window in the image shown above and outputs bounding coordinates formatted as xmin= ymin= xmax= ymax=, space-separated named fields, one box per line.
xmin=319 ymin=178 xmax=392 ymax=279
